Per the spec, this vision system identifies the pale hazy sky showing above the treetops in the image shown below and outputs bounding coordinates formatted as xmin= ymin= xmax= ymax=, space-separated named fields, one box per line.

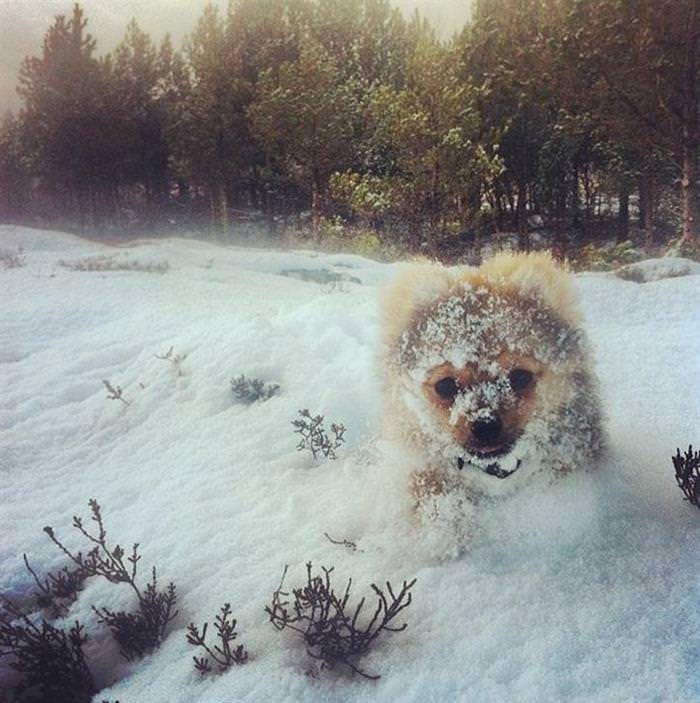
xmin=0 ymin=0 xmax=470 ymax=115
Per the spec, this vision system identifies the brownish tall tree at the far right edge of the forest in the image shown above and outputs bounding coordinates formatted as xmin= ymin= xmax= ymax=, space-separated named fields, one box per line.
xmin=567 ymin=0 xmax=700 ymax=242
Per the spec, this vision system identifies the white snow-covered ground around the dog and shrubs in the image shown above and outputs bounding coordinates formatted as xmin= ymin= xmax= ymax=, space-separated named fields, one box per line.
xmin=0 ymin=227 xmax=700 ymax=703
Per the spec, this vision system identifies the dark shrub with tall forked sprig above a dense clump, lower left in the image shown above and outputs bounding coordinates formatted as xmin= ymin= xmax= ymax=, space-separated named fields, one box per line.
xmin=44 ymin=499 xmax=177 ymax=661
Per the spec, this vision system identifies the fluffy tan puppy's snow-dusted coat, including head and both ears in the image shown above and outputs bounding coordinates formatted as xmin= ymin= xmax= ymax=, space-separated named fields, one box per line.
xmin=382 ymin=254 xmax=603 ymax=507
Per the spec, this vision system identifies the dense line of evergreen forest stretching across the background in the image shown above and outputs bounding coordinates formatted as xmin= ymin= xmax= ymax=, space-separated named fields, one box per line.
xmin=0 ymin=0 xmax=700 ymax=258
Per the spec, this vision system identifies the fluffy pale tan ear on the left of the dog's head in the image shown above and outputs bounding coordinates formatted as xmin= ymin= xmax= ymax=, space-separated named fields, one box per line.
xmin=381 ymin=263 xmax=452 ymax=347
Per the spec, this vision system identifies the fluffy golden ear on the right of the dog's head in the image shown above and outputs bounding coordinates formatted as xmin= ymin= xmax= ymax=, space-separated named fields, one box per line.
xmin=479 ymin=252 xmax=580 ymax=325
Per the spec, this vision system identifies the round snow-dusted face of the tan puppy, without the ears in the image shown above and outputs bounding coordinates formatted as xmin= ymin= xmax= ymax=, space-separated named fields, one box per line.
xmin=386 ymin=254 xmax=597 ymax=490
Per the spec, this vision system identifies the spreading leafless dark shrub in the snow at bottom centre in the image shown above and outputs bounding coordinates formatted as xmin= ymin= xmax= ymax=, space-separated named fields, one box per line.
xmin=265 ymin=562 xmax=416 ymax=679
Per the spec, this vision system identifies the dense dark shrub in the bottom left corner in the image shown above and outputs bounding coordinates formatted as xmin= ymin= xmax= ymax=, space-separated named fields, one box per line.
xmin=0 ymin=598 xmax=97 ymax=703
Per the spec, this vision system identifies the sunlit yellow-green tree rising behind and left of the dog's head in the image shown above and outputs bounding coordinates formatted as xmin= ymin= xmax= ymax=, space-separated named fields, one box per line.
xmin=333 ymin=31 xmax=499 ymax=246
